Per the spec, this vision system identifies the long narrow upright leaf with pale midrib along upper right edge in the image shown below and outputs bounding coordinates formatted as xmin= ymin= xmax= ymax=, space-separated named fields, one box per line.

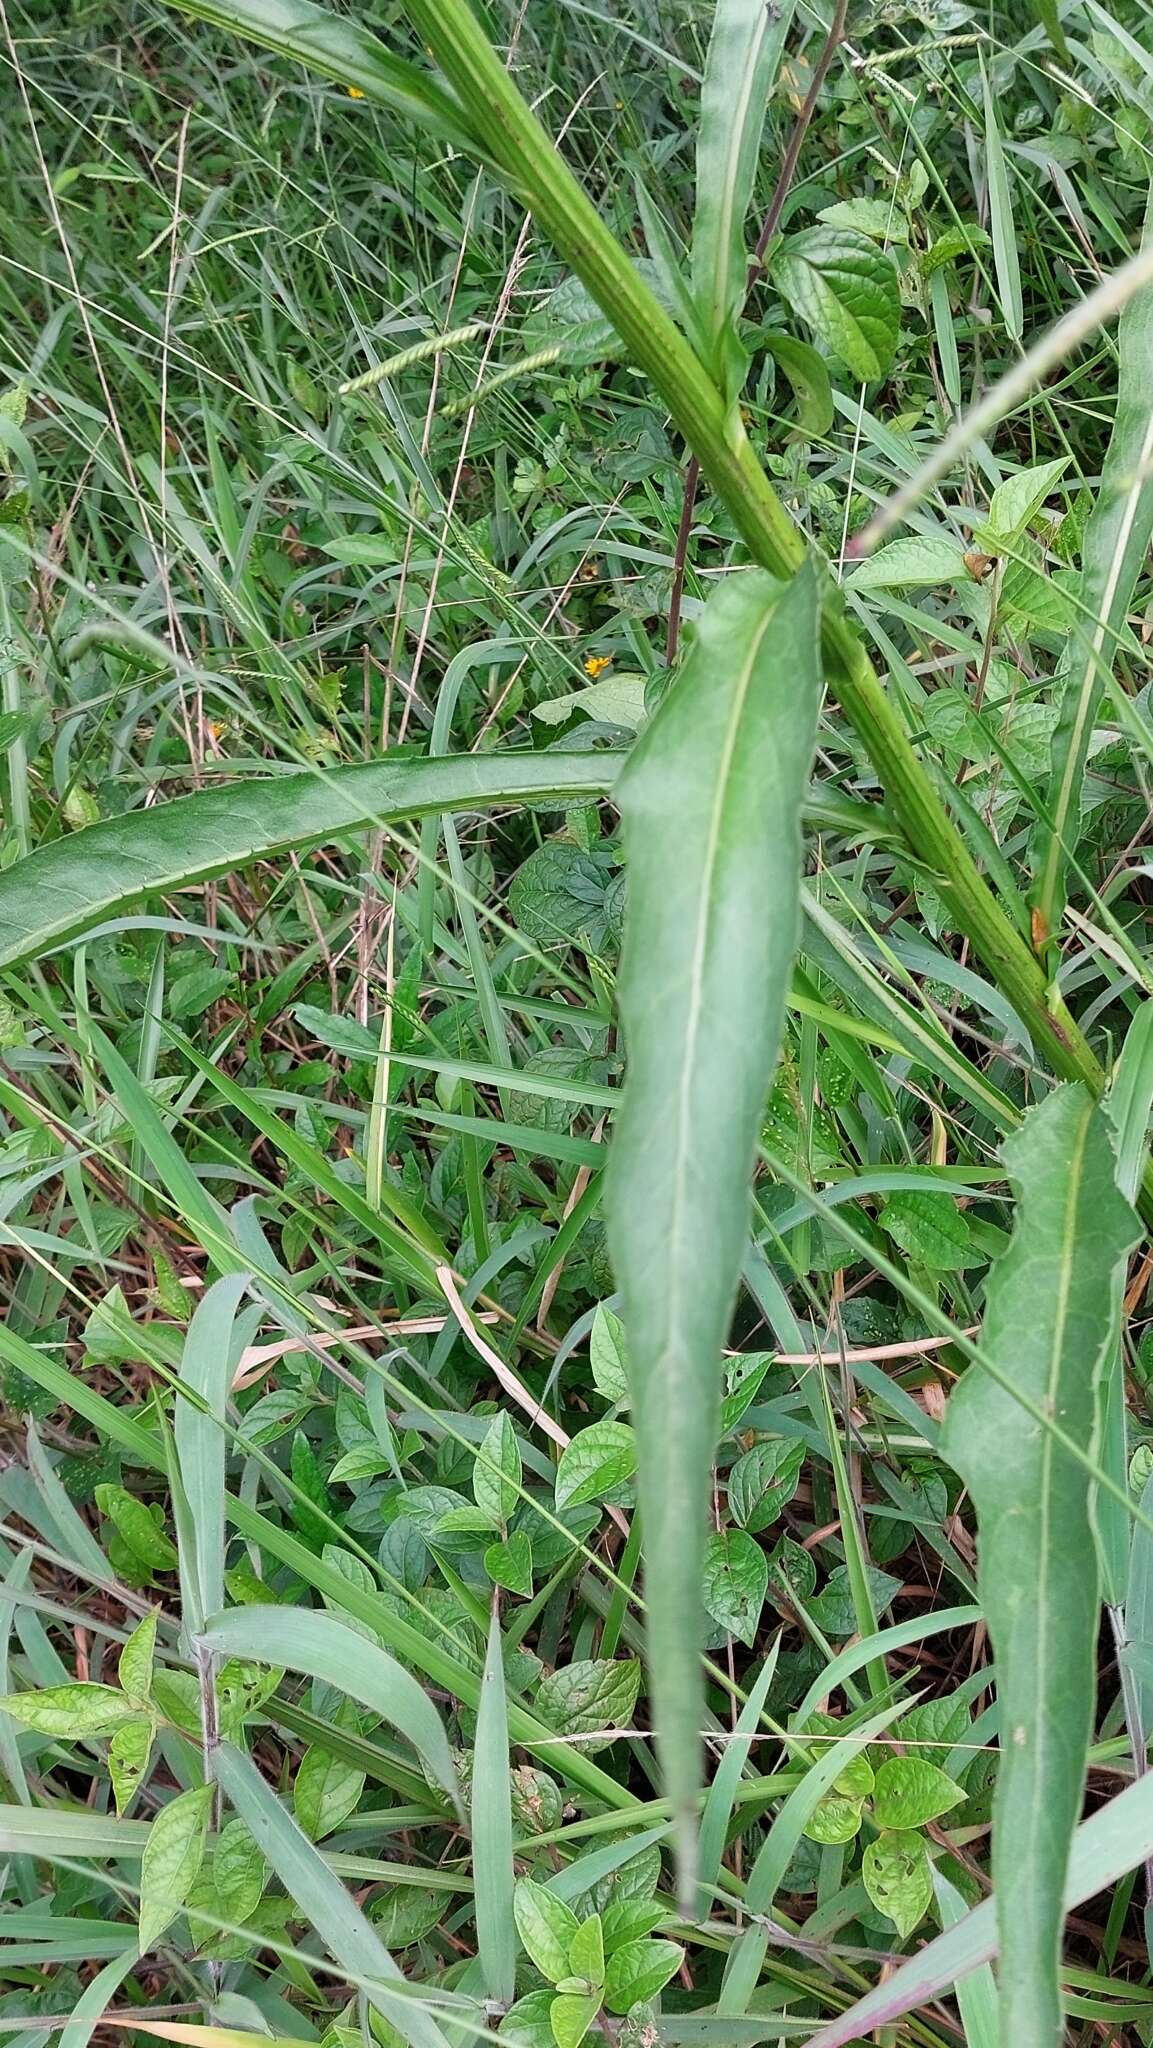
xmin=1032 ymin=186 xmax=1153 ymax=938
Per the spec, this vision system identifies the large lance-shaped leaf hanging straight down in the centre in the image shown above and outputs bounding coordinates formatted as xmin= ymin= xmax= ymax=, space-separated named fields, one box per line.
xmin=606 ymin=565 xmax=819 ymax=1907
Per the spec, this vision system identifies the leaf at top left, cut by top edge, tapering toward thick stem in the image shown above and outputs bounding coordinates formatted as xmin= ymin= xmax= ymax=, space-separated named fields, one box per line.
xmin=166 ymin=0 xmax=477 ymax=152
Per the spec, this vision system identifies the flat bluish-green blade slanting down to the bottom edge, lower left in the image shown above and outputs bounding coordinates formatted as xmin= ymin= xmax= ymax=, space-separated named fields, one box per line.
xmin=215 ymin=1743 xmax=444 ymax=2048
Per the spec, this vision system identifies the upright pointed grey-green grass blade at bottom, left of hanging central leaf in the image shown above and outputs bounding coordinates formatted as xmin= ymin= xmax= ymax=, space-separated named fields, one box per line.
xmin=473 ymin=1599 xmax=516 ymax=2005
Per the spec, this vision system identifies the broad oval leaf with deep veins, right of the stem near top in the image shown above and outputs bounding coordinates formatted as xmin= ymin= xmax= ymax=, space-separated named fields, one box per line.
xmin=772 ymin=227 xmax=901 ymax=383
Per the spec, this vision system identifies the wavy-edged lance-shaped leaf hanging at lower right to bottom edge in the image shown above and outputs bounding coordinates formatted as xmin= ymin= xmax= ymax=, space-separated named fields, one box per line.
xmin=940 ymin=1085 xmax=1137 ymax=2048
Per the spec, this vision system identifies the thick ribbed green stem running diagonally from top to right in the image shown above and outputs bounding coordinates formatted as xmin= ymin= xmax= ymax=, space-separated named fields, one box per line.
xmin=408 ymin=0 xmax=1104 ymax=1094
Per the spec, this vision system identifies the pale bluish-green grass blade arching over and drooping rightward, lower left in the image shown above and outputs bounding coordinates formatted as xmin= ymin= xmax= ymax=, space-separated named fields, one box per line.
xmin=199 ymin=1608 xmax=459 ymax=1802
